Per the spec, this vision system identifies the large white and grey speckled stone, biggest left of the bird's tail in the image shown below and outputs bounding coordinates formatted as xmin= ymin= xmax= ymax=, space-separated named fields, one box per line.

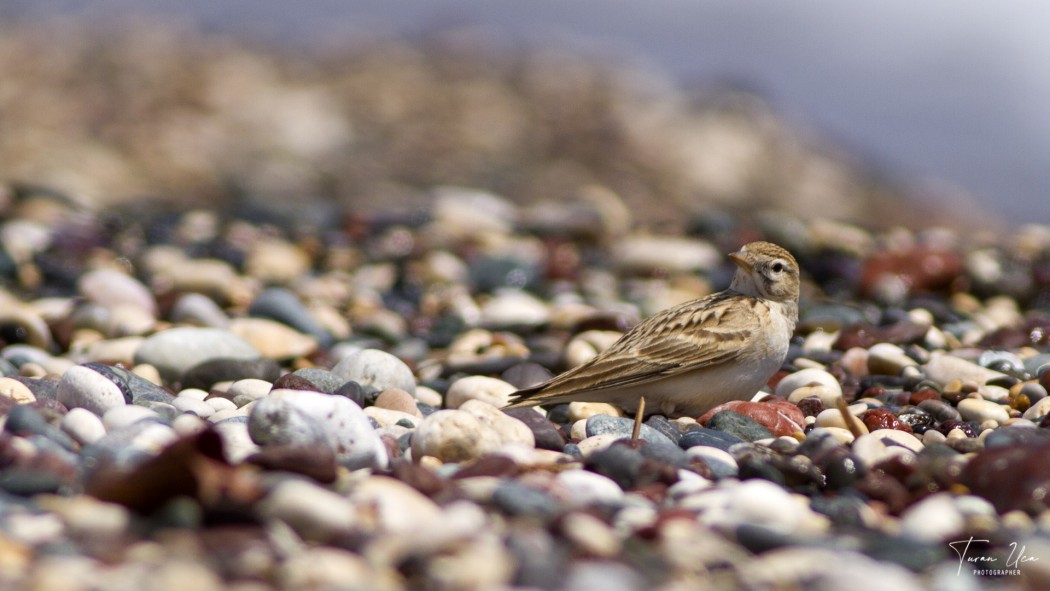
xmin=248 ymin=389 xmax=387 ymax=469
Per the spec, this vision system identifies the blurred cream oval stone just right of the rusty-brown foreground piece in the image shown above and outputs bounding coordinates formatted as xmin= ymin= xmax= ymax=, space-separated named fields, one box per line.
xmin=257 ymin=479 xmax=360 ymax=542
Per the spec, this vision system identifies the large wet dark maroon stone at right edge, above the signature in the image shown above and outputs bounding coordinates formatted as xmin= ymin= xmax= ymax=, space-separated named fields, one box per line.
xmin=960 ymin=441 xmax=1050 ymax=514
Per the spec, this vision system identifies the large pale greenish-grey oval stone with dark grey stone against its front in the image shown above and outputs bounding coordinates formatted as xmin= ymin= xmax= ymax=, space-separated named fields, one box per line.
xmin=135 ymin=326 xmax=259 ymax=385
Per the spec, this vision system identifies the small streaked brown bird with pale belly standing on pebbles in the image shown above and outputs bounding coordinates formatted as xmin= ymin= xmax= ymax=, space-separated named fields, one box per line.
xmin=505 ymin=241 xmax=800 ymax=418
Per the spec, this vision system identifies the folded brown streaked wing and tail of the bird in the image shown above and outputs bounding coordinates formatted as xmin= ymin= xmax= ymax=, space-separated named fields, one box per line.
xmin=503 ymin=292 xmax=758 ymax=405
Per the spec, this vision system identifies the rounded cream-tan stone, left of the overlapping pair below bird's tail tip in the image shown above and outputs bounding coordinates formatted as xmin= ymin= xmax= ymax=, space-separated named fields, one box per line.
xmin=412 ymin=409 xmax=501 ymax=463
